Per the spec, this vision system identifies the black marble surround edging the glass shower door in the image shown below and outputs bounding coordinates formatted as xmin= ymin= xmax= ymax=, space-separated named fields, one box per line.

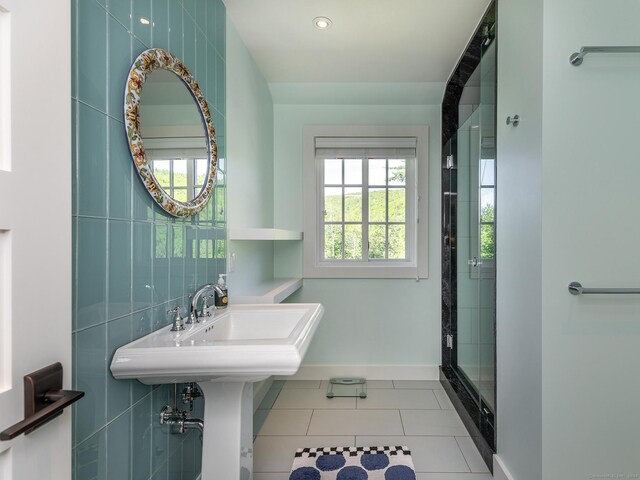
xmin=440 ymin=2 xmax=496 ymax=469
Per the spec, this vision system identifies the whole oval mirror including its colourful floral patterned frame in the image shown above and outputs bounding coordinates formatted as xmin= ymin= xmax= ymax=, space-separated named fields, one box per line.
xmin=124 ymin=48 xmax=217 ymax=217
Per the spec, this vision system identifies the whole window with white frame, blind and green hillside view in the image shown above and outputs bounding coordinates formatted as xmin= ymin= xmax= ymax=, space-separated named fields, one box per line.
xmin=304 ymin=126 xmax=427 ymax=278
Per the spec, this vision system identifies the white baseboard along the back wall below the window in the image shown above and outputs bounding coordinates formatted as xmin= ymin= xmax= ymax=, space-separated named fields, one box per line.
xmin=276 ymin=365 xmax=440 ymax=380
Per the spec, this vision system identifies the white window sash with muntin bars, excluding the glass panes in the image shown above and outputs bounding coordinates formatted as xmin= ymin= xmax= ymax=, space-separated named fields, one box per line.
xmin=316 ymin=153 xmax=417 ymax=266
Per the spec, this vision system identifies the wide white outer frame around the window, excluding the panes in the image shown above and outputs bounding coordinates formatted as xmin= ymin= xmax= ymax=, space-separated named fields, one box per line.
xmin=303 ymin=125 xmax=429 ymax=279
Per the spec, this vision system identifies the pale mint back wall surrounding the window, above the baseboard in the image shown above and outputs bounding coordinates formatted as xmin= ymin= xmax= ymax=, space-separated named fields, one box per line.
xmin=274 ymin=103 xmax=441 ymax=375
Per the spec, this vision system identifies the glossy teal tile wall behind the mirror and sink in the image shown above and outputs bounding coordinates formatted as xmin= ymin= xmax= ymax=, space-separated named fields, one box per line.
xmin=71 ymin=0 xmax=226 ymax=480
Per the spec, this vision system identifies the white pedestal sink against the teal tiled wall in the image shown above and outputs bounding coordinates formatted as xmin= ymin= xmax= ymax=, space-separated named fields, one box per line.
xmin=111 ymin=303 xmax=324 ymax=480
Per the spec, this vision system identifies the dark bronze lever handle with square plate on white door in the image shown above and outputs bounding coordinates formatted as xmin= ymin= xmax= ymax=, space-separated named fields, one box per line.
xmin=0 ymin=363 xmax=84 ymax=440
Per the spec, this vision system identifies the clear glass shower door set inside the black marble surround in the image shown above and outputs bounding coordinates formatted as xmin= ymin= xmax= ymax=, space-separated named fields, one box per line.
xmin=454 ymin=38 xmax=496 ymax=419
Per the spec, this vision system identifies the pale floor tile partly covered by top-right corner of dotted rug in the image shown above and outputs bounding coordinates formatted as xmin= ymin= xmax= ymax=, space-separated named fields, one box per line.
xmin=356 ymin=436 xmax=469 ymax=472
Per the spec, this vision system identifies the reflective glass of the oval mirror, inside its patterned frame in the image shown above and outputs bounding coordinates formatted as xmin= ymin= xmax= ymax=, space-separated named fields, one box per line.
xmin=140 ymin=69 xmax=210 ymax=202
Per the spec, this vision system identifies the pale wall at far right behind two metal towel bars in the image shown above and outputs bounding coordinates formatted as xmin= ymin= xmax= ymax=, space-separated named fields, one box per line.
xmin=542 ymin=0 xmax=640 ymax=479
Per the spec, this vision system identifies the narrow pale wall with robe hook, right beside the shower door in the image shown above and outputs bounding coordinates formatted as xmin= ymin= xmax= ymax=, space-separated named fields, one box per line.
xmin=496 ymin=0 xmax=540 ymax=480
